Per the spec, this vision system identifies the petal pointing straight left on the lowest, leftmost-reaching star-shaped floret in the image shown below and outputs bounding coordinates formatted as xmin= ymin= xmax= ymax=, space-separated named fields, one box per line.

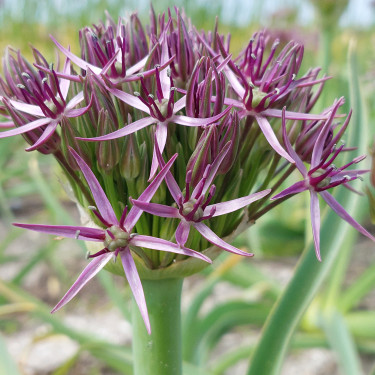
xmin=13 ymin=223 xmax=105 ymax=242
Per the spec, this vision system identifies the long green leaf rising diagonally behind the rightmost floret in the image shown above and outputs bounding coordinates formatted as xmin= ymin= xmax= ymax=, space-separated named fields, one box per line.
xmin=248 ymin=41 xmax=367 ymax=375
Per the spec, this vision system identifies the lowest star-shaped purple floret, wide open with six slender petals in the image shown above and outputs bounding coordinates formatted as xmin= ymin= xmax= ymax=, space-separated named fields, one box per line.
xmin=13 ymin=149 xmax=211 ymax=333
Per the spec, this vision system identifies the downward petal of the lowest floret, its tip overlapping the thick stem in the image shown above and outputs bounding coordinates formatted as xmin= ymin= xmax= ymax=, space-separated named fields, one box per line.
xmin=120 ymin=247 xmax=151 ymax=335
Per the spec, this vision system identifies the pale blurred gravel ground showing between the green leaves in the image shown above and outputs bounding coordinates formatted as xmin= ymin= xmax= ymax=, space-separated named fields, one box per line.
xmin=0 ymin=206 xmax=375 ymax=375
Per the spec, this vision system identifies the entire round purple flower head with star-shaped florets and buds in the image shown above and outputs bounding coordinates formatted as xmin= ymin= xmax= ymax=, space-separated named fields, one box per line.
xmin=0 ymin=8 xmax=374 ymax=332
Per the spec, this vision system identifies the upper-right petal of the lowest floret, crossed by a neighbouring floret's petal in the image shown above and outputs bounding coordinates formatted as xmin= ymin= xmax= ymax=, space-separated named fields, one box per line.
xmin=124 ymin=154 xmax=178 ymax=232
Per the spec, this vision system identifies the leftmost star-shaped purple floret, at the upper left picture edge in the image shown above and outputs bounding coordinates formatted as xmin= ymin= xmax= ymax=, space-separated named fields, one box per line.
xmin=0 ymin=60 xmax=91 ymax=151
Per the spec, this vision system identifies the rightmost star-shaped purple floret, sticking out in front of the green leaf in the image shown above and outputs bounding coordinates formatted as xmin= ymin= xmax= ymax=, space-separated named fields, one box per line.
xmin=271 ymin=106 xmax=375 ymax=261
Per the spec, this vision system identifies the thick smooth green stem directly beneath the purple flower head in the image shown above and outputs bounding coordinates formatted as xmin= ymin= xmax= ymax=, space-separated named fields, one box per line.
xmin=133 ymin=279 xmax=183 ymax=375
